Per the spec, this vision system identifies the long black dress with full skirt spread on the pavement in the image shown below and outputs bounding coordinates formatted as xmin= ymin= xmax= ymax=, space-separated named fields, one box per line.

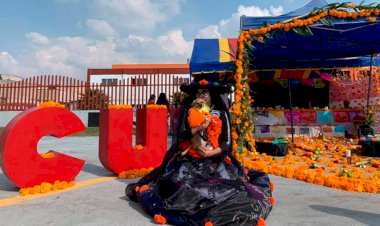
xmin=126 ymin=105 xmax=272 ymax=226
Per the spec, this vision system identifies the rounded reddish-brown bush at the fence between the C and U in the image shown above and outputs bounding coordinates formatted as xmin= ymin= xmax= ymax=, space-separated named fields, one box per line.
xmin=77 ymin=88 xmax=109 ymax=110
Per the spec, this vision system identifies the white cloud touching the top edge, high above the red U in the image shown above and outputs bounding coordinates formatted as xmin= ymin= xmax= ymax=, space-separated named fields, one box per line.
xmin=93 ymin=0 xmax=182 ymax=32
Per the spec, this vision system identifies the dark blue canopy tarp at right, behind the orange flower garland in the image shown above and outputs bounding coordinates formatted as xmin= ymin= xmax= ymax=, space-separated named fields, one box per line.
xmin=241 ymin=0 xmax=380 ymax=69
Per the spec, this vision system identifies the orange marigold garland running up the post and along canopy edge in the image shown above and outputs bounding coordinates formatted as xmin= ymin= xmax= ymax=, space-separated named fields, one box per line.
xmin=230 ymin=3 xmax=380 ymax=153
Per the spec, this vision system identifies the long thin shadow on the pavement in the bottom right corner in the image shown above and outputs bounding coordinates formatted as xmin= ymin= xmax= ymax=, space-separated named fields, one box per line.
xmin=310 ymin=205 xmax=380 ymax=225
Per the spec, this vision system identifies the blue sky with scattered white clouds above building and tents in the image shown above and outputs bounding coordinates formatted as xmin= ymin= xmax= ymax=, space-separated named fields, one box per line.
xmin=0 ymin=0 xmax=368 ymax=79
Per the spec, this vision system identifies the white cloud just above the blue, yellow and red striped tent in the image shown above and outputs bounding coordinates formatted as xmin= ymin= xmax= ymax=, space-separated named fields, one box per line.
xmin=197 ymin=5 xmax=283 ymax=38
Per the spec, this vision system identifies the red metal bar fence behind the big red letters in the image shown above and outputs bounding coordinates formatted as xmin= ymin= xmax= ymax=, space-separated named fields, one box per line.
xmin=0 ymin=74 xmax=189 ymax=111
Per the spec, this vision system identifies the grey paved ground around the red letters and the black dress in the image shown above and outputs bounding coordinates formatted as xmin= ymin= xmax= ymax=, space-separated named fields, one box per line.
xmin=0 ymin=137 xmax=380 ymax=226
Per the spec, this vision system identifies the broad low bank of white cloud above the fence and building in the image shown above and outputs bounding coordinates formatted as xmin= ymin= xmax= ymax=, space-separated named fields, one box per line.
xmin=0 ymin=27 xmax=192 ymax=80
